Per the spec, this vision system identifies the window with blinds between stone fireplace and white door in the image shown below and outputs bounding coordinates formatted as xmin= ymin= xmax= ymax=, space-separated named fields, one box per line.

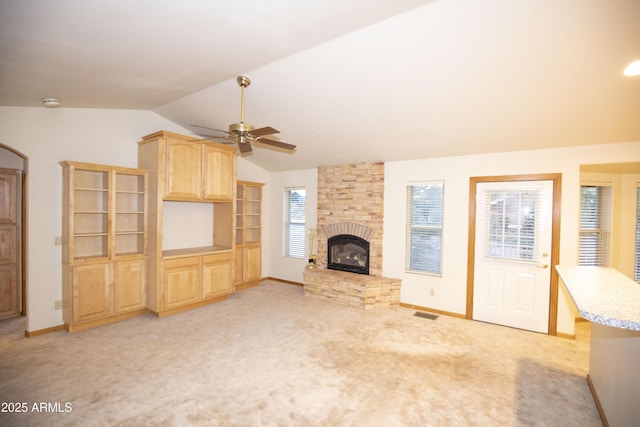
xmin=405 ymin=182 xmax=444 ymax=275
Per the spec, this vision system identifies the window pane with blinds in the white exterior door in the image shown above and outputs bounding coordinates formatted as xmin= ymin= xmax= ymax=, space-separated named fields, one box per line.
xmin=483 ymin=188 xmax=541 ymax=261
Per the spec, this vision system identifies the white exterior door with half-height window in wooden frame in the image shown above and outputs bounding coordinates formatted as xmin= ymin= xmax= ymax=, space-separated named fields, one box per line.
xmin=473 ymin=181 xmax=553 ymax=333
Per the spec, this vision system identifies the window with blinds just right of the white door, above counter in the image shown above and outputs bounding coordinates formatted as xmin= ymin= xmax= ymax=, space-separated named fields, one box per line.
xmin=578 ymin=185 xmax=613 ymax=267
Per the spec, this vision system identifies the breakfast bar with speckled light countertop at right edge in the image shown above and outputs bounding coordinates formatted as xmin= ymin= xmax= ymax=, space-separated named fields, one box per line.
xmin=556 ymin=265 xmax=640 ymax=426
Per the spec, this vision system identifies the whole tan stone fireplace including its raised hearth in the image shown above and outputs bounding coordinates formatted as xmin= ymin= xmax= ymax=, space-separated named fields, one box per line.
xmin=304 ymin=163 xmax=400 ymax=309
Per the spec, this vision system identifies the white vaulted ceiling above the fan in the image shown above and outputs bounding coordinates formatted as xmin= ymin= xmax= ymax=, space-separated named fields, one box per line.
xmin=0 ymin=0 xmax=640 ymax=171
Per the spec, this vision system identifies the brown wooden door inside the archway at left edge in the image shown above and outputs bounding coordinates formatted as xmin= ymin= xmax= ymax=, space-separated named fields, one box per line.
xmin=0 ymin=169 xmax=20 ymax=319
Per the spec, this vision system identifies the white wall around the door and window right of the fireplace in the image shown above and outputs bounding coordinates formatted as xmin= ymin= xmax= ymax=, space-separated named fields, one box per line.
xmin=383 ymin=142 xmax=640 ymax=334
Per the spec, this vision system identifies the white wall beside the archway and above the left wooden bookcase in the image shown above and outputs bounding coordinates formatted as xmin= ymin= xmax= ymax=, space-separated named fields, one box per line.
xmin=0 ymin=107 xmax=194 ymax=331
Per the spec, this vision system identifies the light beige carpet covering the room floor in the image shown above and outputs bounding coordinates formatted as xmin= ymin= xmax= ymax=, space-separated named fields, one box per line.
xmin=0 ymin=282 xmax=601 ymax=427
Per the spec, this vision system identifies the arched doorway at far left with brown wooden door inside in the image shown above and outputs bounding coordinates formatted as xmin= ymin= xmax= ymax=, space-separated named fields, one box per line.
xmin=0 ymin=143 xmax=28 ymax=319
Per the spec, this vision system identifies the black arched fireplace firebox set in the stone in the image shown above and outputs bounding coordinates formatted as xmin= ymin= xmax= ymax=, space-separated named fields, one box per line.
xmin=327 ymin=234 xmax=369 ymax=274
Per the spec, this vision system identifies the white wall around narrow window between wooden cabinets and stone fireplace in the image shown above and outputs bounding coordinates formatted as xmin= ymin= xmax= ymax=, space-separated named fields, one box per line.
xmin=262 ymin=169 xmax=318 ymax=283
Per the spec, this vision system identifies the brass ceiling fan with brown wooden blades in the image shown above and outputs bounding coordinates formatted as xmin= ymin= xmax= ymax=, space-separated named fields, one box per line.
xmin=191 ymin=76 xmax=296 ymax=154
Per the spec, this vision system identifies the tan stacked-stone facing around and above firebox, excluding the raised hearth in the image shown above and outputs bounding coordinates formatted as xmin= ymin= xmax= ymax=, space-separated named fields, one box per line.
xmin=316 ymin=163 xmax=384 ymax=276
